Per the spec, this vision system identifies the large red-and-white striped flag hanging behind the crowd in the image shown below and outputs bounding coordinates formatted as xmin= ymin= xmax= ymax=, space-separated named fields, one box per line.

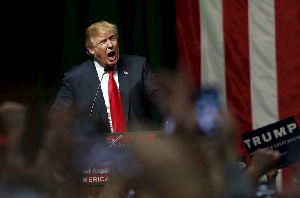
xmin=176 ymin=0 xmax=300 ymax=188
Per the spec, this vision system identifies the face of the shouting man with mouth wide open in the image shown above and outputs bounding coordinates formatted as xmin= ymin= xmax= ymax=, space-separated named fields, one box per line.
xmin=88 ymin=33 xmax=119 ymax=67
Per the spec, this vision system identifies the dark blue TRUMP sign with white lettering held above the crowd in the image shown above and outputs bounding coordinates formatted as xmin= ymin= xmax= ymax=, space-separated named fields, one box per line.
xmin=242 ymin=116 xmax=300 ymax=169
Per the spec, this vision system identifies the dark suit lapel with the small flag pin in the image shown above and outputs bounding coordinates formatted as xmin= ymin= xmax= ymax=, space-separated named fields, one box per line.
xmin=118 ymin=61 xmax=130 ymax=123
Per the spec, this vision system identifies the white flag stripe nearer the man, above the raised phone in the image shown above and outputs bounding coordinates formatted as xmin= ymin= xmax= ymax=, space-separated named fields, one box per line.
xmin=199 ymin=0 xmax=226 ymax=103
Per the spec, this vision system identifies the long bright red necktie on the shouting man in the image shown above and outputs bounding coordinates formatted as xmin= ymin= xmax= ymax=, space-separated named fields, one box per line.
xmin=108 ymin=70 xmax=126 ymax=132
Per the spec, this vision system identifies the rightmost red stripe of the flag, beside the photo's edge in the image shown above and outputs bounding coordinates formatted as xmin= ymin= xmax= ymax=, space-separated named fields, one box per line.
xmin=275 ymin=0 xmax=300 ymax=187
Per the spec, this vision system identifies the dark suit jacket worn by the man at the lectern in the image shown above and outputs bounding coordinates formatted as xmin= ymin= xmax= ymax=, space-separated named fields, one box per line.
xmin=50 ymin=54 xmax=165 ymax=133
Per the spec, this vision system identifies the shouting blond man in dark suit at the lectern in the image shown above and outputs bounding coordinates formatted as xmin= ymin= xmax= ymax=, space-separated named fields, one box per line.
xmin=50 ymin=21 xmax=166 ymax=133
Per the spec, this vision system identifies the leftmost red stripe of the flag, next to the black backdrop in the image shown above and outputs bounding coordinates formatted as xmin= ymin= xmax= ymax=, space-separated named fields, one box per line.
xmin=176 ymin=0 xmax=201 ymax=87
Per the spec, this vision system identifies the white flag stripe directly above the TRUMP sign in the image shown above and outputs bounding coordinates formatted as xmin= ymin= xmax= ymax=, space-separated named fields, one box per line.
xmin=248 ymin=0 xmax=278 ymax=129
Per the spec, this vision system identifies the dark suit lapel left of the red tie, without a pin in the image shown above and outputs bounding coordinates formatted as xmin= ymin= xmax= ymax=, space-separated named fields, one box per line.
xmin=85 ymin=59 xmax=110 ymax=128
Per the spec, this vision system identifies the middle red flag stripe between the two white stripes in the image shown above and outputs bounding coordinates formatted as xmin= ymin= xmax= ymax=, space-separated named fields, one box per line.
xmin=223 ymin=0 xmax=252 ymax=160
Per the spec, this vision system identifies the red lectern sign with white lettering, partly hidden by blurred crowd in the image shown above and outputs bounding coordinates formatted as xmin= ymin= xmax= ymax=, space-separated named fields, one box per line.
xmin=82 ymin=132 xmax=162 ymax=186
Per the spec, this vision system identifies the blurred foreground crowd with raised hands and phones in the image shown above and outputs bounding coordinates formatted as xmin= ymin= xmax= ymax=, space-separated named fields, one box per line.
xmin=0 ymin=72 xmax=300 ymax=198
